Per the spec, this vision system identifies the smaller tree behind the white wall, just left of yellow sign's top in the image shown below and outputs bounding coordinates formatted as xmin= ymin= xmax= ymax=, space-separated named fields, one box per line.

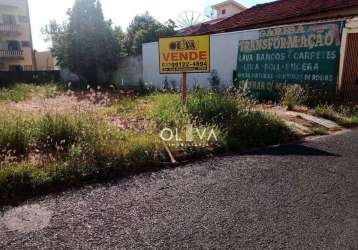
xmin=126 ymin=12 xmax=175 ymax=55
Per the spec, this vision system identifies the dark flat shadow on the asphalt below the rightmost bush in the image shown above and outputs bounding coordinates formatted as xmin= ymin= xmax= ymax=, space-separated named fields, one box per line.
xmin=245 ymin=145 xmax=340 ymax=157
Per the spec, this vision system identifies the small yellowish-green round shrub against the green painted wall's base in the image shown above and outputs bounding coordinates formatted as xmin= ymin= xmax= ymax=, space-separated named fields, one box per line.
xmin=281 ymin=84 xmax=306 ymax=110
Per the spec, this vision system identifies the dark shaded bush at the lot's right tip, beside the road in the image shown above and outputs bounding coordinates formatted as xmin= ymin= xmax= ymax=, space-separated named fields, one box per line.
xmin=226 ymin=111 xmax=292 ymax=151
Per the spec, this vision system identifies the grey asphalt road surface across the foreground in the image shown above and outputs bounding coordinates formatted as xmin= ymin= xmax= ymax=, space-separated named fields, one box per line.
xmin=0 ymin=131 xmax=358 ymax=249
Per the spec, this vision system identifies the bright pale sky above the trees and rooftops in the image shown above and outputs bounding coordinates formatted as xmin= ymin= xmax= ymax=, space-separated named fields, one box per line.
xmin=29 ymin=0 xmax=272 ymax=51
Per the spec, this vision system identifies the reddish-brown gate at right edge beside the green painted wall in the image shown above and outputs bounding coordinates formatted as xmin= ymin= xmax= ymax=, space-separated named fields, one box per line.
xmin=341 ymin=33 xmax=358 ymax=102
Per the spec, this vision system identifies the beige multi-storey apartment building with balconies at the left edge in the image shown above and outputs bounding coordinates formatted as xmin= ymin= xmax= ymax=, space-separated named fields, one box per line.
xmin=0 ymin=0 xmax=36 ymax=71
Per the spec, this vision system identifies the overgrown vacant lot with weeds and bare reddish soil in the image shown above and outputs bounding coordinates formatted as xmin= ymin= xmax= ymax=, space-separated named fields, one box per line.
xmin=0 ymin=84 xmax=295 ymax=203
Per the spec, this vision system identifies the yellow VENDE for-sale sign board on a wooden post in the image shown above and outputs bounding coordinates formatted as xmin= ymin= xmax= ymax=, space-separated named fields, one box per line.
xmin=159 ymin=35 xmax=210 ymax=74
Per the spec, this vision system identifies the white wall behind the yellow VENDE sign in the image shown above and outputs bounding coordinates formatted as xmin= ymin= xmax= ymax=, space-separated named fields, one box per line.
xmin=143 ymin=30 xmax=259 ymax=88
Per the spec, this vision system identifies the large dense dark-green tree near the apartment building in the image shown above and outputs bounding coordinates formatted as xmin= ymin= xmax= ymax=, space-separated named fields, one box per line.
xmin=43 ymin=0 xmax=120 ymax=85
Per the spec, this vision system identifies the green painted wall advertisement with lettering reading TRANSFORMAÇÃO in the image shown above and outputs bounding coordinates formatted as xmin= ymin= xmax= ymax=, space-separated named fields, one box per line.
xmin=237 ymin=21 xmax=345 ymax=89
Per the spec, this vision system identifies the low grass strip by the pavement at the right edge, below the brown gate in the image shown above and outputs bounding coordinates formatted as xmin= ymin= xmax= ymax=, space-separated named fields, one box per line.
xmin=314 ymin=105 xmax=358 ymax=127
